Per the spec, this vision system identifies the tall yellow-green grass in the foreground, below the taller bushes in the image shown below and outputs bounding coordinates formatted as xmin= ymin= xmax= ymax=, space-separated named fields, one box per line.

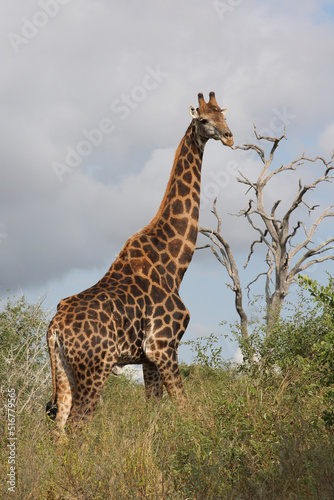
xmin=0 ymin=292 xmax=334 ymax=500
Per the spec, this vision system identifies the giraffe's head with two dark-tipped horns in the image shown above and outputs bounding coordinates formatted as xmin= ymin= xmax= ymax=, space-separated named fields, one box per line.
xmin=189 ymin=92 xmax=234 ymax=146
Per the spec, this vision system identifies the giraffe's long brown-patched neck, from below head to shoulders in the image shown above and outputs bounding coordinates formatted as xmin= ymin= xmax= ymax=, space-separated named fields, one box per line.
xmin=143 ymin=122 xmax=205 ymax=284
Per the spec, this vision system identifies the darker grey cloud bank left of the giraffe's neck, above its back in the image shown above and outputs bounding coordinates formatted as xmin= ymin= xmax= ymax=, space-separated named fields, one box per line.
xmin=2 ymin=149 xmax=173 ymax=288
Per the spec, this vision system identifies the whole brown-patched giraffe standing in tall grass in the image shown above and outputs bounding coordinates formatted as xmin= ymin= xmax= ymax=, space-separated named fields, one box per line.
xmin=46 ymin=92 xmax=233 ymax=430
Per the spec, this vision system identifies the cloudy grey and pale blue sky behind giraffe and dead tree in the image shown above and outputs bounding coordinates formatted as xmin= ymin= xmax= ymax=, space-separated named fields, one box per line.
xmin=0 ymin=0 xmax=334 ymax=362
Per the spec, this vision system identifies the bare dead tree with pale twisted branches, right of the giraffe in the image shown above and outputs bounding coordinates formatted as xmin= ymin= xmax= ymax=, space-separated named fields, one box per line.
xmin=200 ymin=126 xmax=334 ymax=335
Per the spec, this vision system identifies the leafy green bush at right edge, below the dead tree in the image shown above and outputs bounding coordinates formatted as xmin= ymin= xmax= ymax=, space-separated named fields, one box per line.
xmin=235 ymin=277 xmax=334 ymax=426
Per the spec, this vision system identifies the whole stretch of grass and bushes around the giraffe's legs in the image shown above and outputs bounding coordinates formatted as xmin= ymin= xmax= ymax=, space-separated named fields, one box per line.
xmin=0 ymin=289 xmax=334 ymax=500
